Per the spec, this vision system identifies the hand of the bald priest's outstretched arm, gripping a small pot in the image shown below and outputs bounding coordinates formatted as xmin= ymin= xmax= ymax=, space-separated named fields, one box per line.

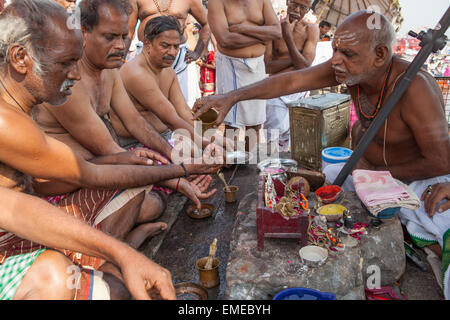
xmin=192 ymin=94 xmax=234 ymax=127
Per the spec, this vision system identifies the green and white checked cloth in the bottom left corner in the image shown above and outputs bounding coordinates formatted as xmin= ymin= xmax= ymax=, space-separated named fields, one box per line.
xmin=0 ymin=249 xmax=45 ymax=300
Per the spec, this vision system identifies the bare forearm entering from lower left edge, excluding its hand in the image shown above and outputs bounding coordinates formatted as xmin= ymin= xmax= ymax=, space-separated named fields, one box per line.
xmin=0 ymin=188 xmax=132 ymax=265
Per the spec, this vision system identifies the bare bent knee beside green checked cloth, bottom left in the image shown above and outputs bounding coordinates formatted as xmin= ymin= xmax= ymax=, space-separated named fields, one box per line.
xmin=14 ymin=250 xmax=75 ymax=300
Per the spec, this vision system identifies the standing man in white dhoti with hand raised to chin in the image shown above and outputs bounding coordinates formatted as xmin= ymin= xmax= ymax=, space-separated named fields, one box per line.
xmin=264 ymin=0 xmax=319 ymax=152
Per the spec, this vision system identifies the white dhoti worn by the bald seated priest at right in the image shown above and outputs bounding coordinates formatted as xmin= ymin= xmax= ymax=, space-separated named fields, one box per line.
xmin=323 ymin=164 xmax=450 ymax=300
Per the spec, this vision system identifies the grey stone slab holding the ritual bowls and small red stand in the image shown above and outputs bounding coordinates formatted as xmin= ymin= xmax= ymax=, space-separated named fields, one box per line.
xmin=225 ymin=192 xmax=406 ymax=300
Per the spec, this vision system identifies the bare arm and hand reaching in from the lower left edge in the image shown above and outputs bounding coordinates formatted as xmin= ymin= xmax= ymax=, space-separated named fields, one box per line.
xmin=0 ymin=187 xmax=176 ymax=299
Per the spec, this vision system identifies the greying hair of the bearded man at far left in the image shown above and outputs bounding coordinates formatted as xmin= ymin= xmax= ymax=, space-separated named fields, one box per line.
xmin=0 ymin=0 xmax=68 ymax=76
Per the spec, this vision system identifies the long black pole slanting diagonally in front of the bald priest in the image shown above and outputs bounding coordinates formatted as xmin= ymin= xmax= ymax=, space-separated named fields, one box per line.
xmin=333 ymin=7 xmax=450 ymax=186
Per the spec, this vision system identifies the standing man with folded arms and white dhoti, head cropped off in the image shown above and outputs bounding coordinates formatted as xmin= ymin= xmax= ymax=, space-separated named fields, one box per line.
xmin=208 ymin=0 xmax=281 ymax=151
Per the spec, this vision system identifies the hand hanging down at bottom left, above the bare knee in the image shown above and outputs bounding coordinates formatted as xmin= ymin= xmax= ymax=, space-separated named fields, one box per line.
xmin=119 ymin=250 xmax=176 ymax=300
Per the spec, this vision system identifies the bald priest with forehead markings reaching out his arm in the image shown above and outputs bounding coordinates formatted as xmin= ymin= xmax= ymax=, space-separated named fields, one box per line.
xmin=194 ymin=11 xmax=450 ymax=299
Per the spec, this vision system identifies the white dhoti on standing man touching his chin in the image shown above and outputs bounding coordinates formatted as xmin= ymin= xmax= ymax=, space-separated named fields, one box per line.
xmin=264 ymin=91 xmax=309 ymax=152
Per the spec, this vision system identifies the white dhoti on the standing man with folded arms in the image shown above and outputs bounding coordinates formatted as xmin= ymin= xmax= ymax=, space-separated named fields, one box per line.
xmin=216 ymin=52 xmax=266 ymax=128
